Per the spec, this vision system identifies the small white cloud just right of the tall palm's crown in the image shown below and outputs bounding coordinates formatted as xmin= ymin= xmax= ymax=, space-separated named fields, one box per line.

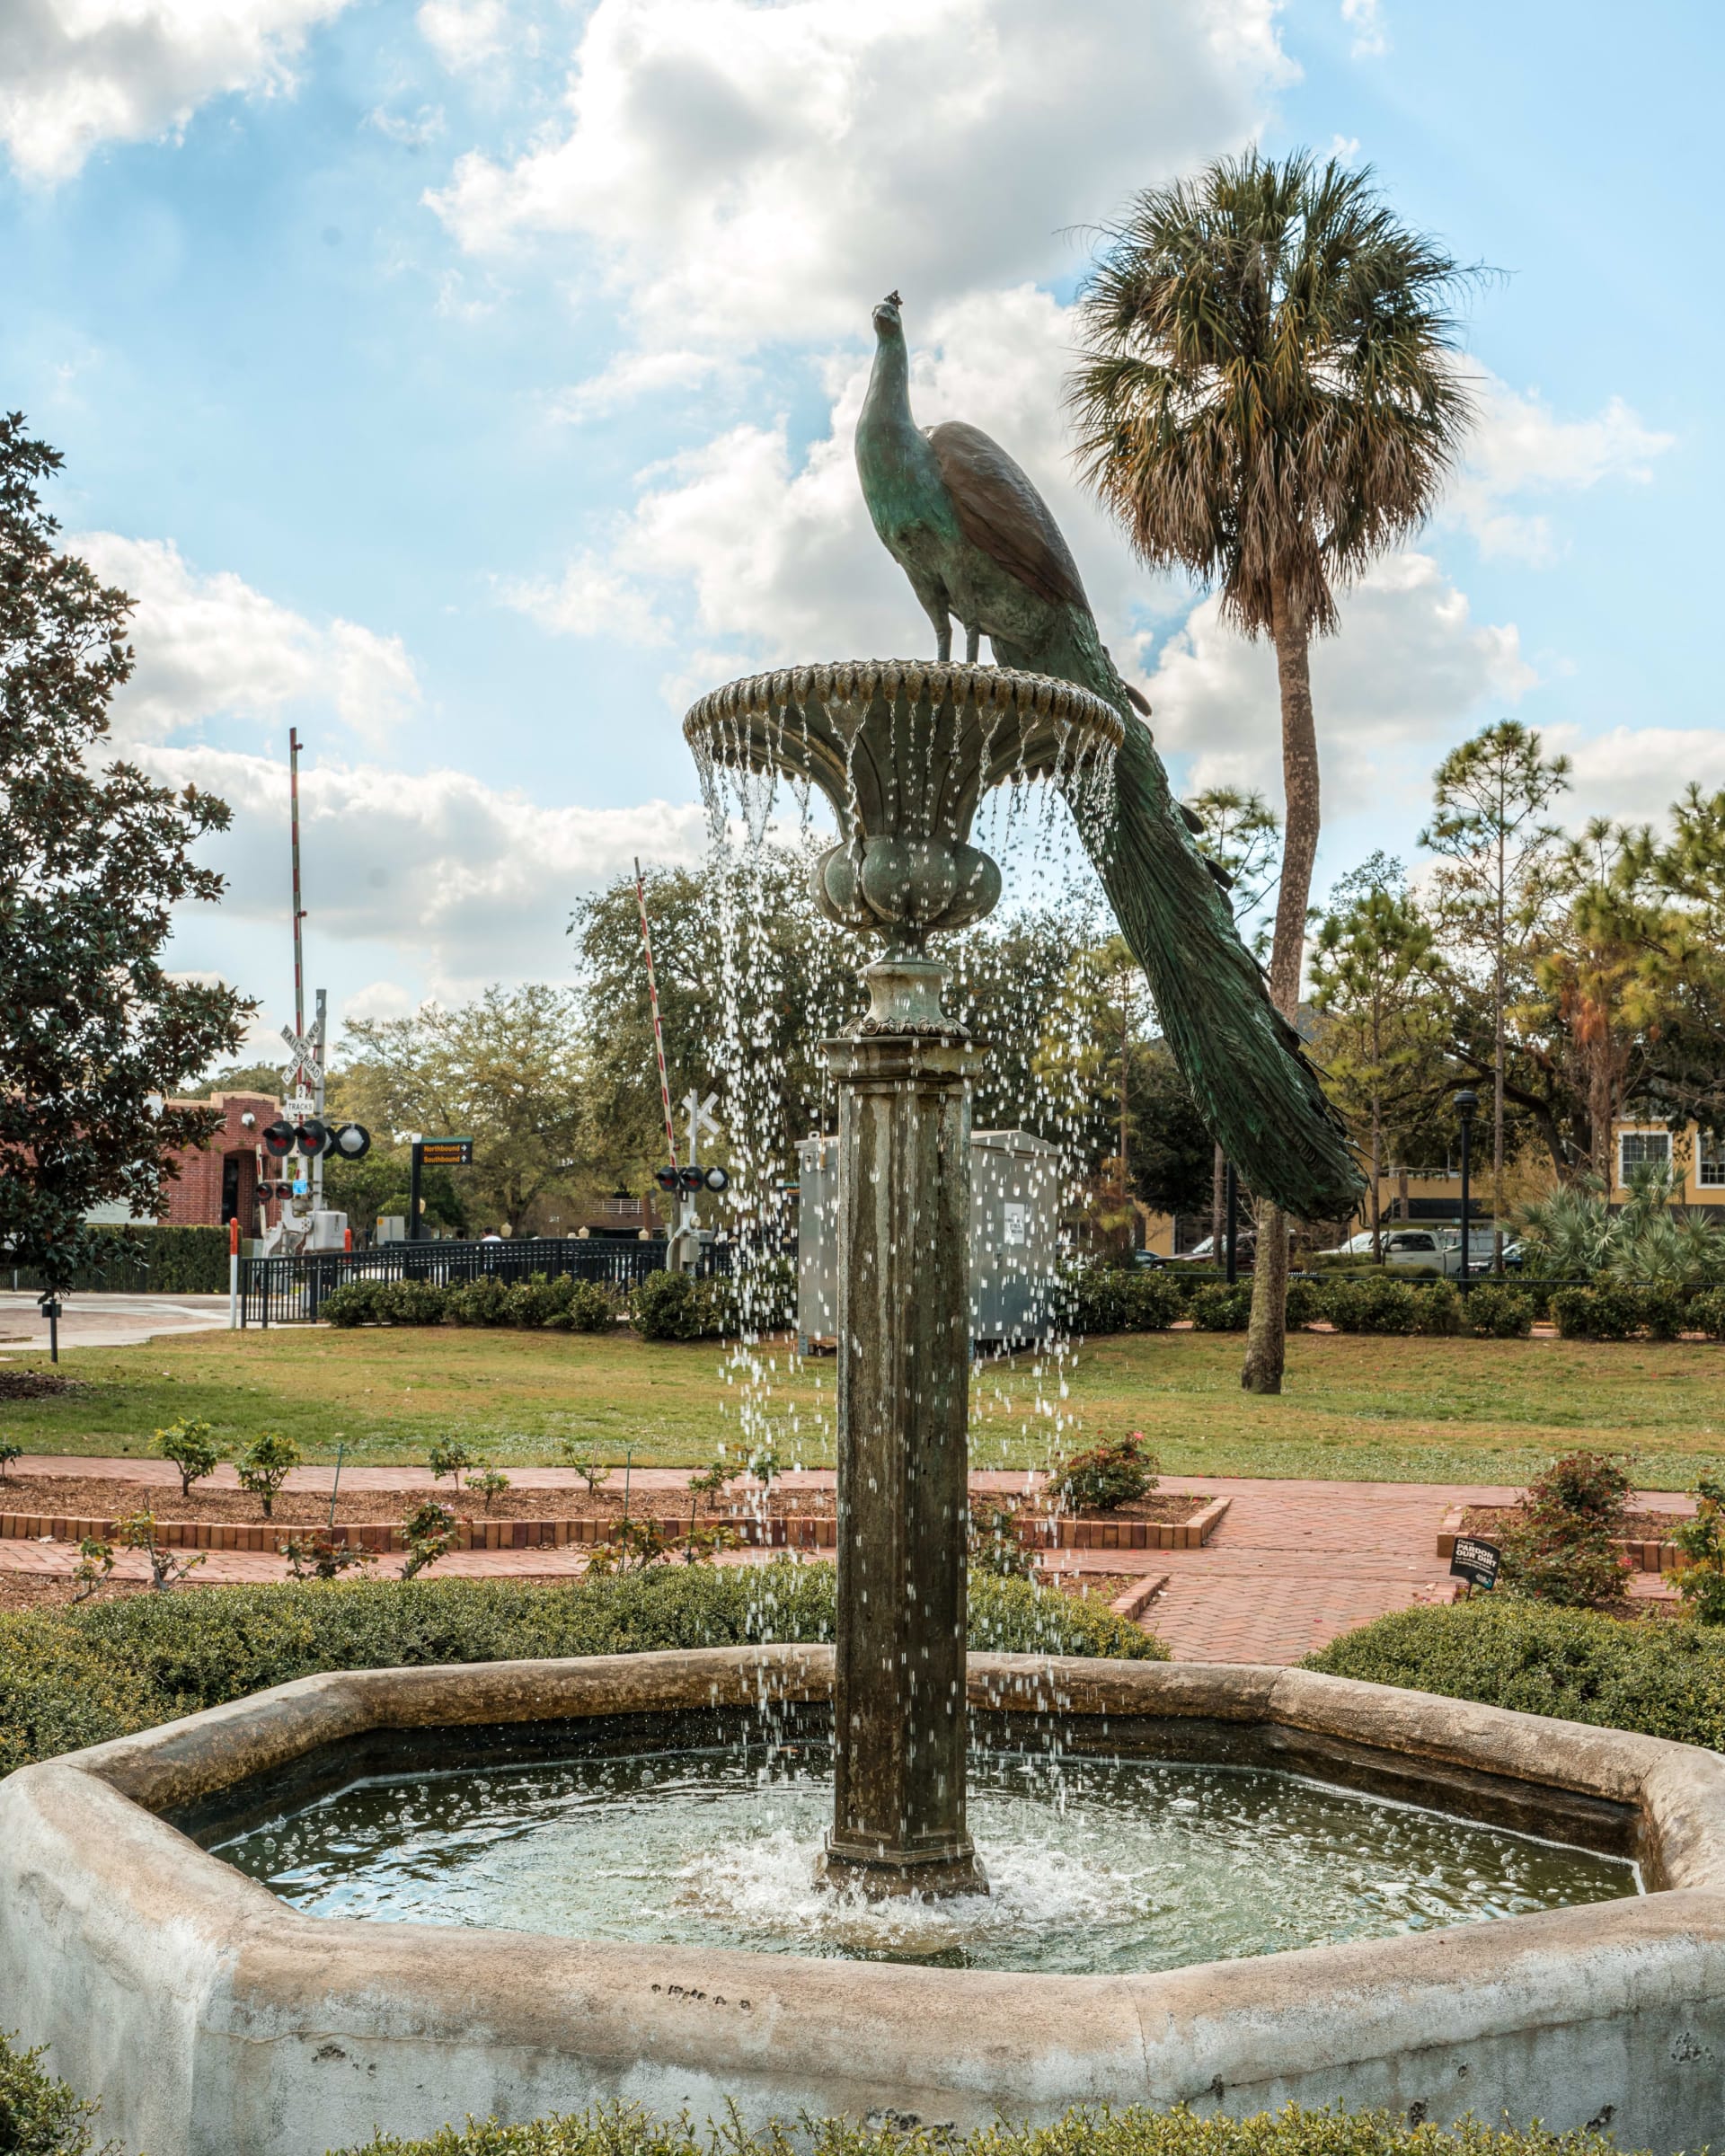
xmin=1445 ymin=373 xmax=1676 ymax=562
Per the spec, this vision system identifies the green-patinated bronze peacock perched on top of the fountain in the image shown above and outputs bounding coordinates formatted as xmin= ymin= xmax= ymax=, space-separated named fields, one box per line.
xmin=856 ymin=293 xmax=1360 ymax=1218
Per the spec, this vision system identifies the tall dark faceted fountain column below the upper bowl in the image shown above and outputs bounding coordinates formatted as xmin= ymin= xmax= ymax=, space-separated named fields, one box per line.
xmin=821 ymin=958 xmax=987 ymax=1895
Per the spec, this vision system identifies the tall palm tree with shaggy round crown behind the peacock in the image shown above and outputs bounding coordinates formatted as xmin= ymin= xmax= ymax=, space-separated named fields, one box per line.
xmin=1069 ymin=151 xmax=1473 ymax=1392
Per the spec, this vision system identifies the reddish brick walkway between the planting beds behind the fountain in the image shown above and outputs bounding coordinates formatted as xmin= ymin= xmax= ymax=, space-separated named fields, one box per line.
xmin=0 ymin=1457 xmax=1688 ymax=1662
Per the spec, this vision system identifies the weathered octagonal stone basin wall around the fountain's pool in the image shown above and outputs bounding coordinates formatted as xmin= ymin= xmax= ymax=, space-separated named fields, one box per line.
xmin=0 ymin=1648 xmax=1725 ymax=2156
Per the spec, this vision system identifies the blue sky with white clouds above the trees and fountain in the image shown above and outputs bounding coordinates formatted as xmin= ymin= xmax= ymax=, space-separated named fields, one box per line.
xmin=0 ymin=0 xmax=1725 ymax=1069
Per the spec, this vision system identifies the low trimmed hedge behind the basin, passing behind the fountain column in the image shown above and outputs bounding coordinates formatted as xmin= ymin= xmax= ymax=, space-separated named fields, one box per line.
xmin=0 ymin=1561 xmax=1166 ymax=1776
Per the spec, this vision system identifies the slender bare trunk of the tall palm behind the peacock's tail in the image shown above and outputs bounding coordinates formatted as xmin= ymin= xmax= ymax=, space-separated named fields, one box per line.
xmin=1240 ymin=578 xmax=1320 ymax=1392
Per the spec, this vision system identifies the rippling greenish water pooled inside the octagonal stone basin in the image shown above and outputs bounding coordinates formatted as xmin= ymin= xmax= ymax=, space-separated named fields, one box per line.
xmin=216 ymin=1742 xmax=1641 ymax=1975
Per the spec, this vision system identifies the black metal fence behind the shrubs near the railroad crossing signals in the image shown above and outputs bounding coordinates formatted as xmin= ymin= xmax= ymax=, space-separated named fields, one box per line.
xmin=239 ymin=1235 xmax=731 ymax=1326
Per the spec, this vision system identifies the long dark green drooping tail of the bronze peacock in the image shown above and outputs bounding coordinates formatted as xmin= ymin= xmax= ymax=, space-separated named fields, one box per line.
xmin=992 ymin=605 xmax=1363 ymax=1220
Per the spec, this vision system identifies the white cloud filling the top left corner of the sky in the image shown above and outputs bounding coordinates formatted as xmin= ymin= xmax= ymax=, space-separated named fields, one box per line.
xmin=0 ymin=0 xmax=347 ymax=181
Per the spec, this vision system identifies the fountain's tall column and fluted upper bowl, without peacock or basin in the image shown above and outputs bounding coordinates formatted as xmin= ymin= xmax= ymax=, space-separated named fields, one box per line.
xmin=684 ymin=662 xmax=1121 ymax=1895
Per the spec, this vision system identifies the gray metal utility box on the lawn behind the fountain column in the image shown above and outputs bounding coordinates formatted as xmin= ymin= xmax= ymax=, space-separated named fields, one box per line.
xmin=796 ymin=1130 xmax=1066 ymax=1354
